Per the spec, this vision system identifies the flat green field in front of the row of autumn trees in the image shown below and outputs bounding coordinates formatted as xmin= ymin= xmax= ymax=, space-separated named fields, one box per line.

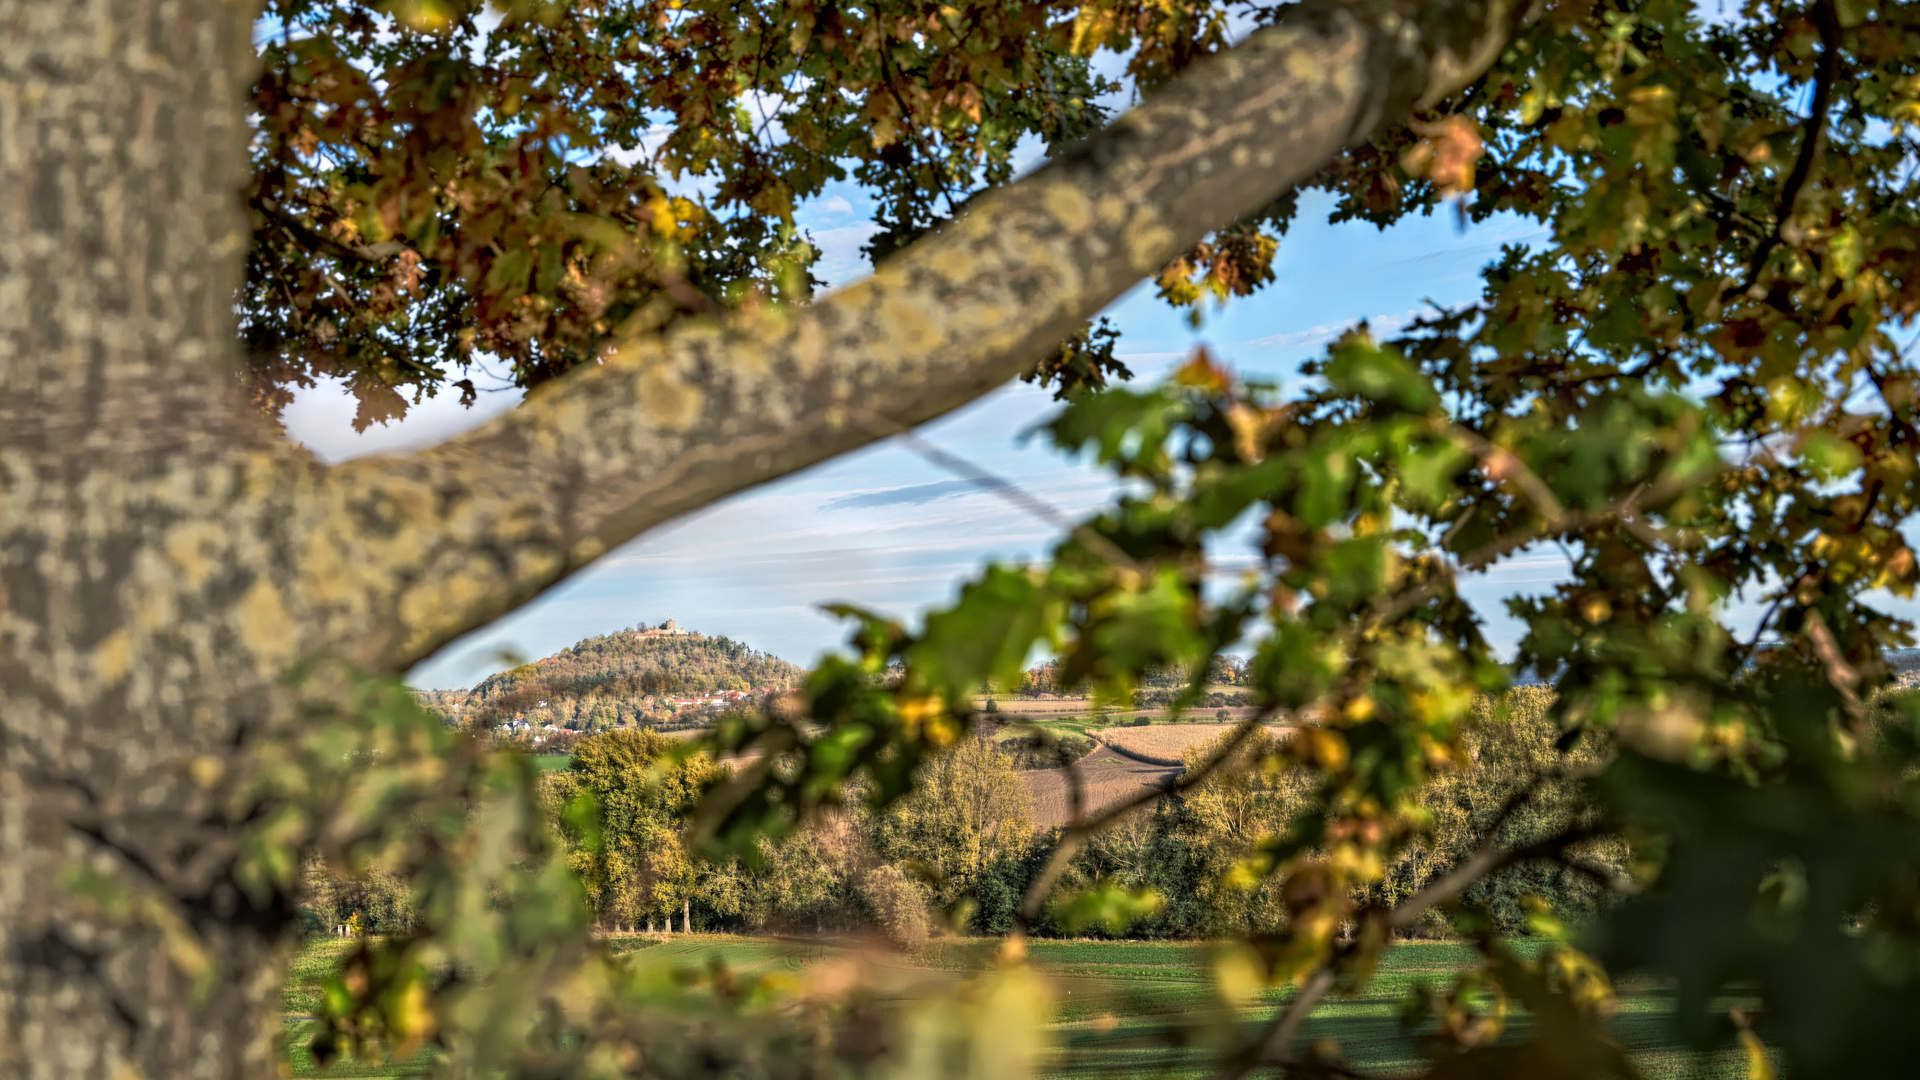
xmin=284 ymin=934 xmax=1743 ymax=1078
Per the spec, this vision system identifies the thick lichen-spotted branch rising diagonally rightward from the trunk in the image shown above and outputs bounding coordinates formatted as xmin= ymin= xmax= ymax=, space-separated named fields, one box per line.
xmin=301 ymin=0 xmax=1517 ymax=667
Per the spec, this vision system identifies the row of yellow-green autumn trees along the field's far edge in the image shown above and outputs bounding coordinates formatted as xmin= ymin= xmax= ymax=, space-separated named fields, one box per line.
xmin=309 ymin=688 xmax=1624 ymax=944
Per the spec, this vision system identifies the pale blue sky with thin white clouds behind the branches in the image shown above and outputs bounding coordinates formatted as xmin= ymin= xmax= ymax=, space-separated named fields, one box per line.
xmin=286 ymin=186 xmax=1597 ymax=688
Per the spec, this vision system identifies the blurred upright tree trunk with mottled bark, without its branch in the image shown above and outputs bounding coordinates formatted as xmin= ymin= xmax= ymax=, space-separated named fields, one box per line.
xmin=0 ymin=0 xmax=292 ymax=1080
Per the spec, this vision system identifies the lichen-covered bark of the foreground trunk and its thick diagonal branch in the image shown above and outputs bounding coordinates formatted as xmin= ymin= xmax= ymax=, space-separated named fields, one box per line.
xmin=0 ymin=0 xmax=1528 ymax=1080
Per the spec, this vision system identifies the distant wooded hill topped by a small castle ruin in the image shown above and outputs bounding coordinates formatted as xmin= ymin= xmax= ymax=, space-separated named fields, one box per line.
xmin=420 ymin=623 xmax=806 ymax=730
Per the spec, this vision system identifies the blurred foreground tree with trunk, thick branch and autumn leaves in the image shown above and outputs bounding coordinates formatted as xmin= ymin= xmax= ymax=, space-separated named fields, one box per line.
xmin=22 ymin=0 xmax=1920 ymax=1078
